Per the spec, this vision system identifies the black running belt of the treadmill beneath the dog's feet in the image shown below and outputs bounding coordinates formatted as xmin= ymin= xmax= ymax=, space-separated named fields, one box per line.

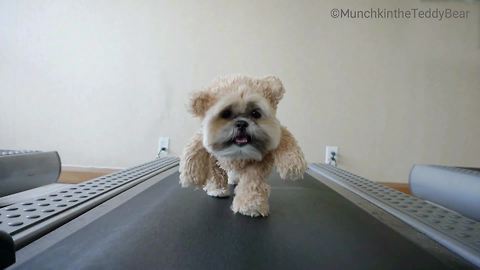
xmin=16 ymin=173 xmax=456 ymax=270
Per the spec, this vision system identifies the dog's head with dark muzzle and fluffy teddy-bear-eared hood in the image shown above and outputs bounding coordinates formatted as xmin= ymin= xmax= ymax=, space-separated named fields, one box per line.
xmin=188 ymin=77 xmax=284 ymax=160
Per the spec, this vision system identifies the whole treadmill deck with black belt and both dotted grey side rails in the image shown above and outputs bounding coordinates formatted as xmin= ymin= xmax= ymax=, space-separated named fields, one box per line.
xmin=0 ymin=157 xmax=480 ymax=269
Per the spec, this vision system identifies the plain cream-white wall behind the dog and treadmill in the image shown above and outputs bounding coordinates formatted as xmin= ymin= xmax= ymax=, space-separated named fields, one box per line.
xmin=0 ymin=0 xmax=480 ymax=181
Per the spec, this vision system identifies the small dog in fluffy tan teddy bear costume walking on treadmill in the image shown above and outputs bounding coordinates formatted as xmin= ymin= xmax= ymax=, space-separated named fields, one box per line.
xmin=180 ymin=76 xmax=307 ymax=217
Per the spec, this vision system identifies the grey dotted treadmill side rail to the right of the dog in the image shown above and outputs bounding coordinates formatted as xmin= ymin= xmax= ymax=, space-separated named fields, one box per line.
xmin=309 ymin=164 xmax=480 ymax=267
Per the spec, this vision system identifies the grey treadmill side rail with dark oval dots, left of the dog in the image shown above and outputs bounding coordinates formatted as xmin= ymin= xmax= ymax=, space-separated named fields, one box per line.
xmin=0 ymin=157 xmax=178 ymax=250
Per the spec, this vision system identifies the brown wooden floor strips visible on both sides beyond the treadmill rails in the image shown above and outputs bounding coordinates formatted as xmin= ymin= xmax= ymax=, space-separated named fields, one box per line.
xmin=60 ymin=168 xmax=411 ymax=194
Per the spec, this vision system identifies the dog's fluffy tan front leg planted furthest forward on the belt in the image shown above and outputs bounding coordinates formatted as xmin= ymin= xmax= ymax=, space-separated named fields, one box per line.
xmin=232 ymin=170 xmax=270 ymax=217
